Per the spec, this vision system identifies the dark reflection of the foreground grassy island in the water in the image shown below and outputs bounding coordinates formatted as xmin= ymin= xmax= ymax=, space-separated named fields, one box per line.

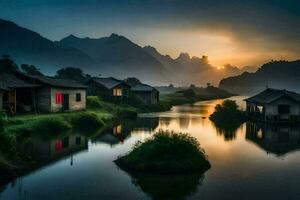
xmin=130 ymin=173 xmax=204 ymax=200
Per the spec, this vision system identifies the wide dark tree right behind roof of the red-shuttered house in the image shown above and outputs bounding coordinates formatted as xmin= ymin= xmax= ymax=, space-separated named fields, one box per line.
xmin=55 ymin=67 xmax=91 ymax=83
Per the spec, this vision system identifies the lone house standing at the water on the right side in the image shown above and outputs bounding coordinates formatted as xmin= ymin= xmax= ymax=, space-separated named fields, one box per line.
xmin=245 ymin=88 xmax=300 ymax=123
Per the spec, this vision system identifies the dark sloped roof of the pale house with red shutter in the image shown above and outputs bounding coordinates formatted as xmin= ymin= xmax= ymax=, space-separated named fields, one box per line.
xmin=25 ymin=75 xmax=86 ymax=88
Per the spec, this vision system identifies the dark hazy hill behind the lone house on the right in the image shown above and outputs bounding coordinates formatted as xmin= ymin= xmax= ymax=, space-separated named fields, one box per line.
xmin=219 ymin=60 xmax=300 ymax=94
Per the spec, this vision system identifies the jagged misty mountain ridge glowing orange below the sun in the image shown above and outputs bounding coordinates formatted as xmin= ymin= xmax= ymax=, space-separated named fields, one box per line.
xmin=143 ymin=46 xmax=242 ymax=85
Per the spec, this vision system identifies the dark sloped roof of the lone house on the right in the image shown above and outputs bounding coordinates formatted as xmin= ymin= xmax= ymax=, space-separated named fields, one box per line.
xmin=245 ymin=88 xmax=300 ymax=104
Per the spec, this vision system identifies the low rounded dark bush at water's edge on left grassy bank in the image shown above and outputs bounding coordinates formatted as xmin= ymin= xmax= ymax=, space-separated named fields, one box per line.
xmin=71 ymin=112 xmax=104 ymax=131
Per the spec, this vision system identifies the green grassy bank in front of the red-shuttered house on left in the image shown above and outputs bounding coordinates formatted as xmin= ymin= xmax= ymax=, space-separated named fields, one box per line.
xmin=0 ymin=96 xmax=137 ymax=136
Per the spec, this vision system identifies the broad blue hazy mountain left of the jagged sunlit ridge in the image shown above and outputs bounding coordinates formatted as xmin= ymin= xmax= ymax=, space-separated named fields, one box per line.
xmin=57 ymin=34 xmax=168 ymax=83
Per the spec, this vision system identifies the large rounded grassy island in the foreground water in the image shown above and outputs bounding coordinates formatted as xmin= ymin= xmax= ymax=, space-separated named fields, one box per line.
xmin=115 ymin=130 xmax=211 ymax=174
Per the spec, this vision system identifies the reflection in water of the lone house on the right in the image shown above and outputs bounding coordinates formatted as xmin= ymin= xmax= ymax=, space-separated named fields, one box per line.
xmin=246 ymin=123 xmax=300 ymax=156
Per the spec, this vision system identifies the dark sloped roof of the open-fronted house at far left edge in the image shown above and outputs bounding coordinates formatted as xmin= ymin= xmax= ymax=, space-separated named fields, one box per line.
xmin=0 ymin=72 xmax=38 ymax=90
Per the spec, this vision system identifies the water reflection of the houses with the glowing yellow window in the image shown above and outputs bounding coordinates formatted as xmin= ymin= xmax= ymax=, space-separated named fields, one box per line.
xmin=94 ymin=118 xmax=158 ymax=146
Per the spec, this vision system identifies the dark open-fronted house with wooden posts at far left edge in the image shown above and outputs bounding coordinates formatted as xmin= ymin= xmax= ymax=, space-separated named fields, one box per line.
xmin=0 ymin=73 xmax=38 ymax=114
